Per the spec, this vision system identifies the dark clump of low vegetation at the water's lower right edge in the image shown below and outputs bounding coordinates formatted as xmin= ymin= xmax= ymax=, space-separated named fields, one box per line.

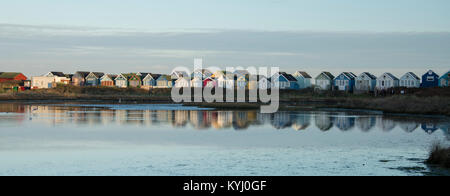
xmin=426 ymin=143 xmax=450 ymax=168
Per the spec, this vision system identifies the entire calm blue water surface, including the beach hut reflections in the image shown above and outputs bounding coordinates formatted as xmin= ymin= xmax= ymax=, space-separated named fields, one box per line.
xmin=0 ymin=104 xmax=450 ymax=175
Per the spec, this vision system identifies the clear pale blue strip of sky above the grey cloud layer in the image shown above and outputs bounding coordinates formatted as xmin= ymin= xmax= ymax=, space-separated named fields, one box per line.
xmin=0 ymin=0 xmax=450 ymax=31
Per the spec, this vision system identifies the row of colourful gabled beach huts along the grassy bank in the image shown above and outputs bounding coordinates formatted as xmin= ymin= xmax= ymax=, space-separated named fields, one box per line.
xmin=6 ymin=69 xmax=450 ymax=92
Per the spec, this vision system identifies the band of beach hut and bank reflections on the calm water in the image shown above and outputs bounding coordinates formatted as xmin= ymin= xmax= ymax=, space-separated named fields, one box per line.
xmin=0 ymin=104 xmax=450 ymax=139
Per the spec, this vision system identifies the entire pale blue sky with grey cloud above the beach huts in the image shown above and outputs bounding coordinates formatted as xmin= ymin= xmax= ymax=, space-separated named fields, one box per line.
xmin=0 ymin=0 xmax=450 ymax=76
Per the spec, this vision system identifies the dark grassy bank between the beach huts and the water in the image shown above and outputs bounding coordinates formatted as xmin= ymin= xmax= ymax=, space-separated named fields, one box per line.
xmin=0 ymin=86 xmax=450 ymax=117
